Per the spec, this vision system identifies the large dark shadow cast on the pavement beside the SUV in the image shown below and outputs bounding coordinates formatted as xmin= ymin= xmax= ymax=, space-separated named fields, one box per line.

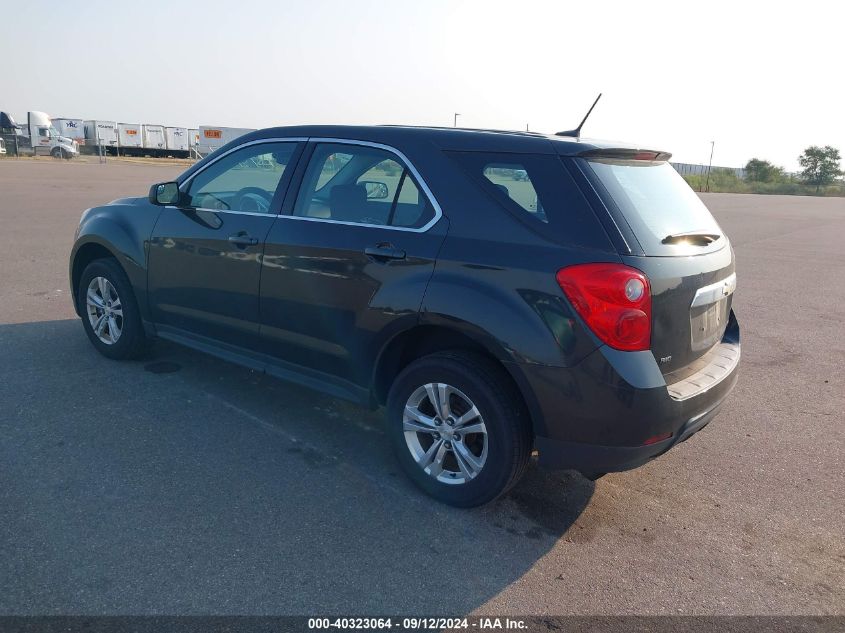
xmin=0 ymin=320 xmax=594 ymax=615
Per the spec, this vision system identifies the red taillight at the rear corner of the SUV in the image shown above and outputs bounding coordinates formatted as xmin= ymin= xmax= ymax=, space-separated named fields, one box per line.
xmin=557 ymin=264 xmax=651 ymax=352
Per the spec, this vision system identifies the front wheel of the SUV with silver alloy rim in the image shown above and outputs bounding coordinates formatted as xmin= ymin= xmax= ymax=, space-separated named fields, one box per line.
xmin=76 ymin=259 xmax=148 ymax=360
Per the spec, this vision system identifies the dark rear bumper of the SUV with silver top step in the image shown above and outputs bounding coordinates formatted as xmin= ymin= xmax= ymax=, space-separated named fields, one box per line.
xmin=510 ymin=312 xmax=740 ymax=475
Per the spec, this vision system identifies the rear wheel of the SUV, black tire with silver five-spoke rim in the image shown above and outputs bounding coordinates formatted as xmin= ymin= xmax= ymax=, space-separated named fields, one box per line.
xmin=387 ymin=351 xmax=532 ymax=507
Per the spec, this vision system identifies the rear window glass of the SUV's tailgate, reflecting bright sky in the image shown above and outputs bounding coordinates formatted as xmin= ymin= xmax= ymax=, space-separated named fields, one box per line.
xmin=587 ymin=158 xmax=725 ymax=255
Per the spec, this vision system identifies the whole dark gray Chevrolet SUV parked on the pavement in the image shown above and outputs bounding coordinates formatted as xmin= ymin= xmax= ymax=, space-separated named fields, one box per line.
xmin=70 ymin=126 xmax=740 ymax=506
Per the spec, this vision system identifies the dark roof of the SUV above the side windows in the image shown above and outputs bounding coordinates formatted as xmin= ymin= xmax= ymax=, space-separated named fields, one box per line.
xmin=249 ymin=125 xmax=664 ymax=155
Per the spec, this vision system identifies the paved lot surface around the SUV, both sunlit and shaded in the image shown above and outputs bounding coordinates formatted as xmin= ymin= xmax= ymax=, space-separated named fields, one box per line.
xmin=0 ymin=159 xmax=845 ymax=616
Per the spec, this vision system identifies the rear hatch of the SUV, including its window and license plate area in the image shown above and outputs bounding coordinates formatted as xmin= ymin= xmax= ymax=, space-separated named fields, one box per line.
xmin=575 ymin=150 xmax=736 ymax=376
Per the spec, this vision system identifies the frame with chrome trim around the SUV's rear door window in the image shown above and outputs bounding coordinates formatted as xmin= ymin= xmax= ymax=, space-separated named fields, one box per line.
xmin=276 ymin=136 xmax=443 ymax=233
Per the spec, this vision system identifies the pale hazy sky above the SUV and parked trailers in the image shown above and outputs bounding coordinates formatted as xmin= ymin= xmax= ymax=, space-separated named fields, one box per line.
xmin=0 ymin=0 xmax=845 ymax=171
